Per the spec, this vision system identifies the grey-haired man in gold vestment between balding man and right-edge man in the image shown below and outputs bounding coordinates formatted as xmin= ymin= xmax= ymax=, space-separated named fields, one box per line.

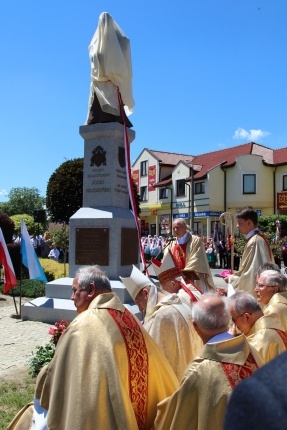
xmin=229 ymin=291 xmax=287 ymax=364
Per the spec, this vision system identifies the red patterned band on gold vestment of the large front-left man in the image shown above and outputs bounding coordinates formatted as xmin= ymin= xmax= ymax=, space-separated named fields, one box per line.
xmin=107 ymin=309 xmax=148 ymax=430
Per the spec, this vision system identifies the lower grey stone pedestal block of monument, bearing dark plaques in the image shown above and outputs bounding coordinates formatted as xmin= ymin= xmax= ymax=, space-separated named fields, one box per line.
xmin=69 ymin=207 xmax=139 ymax=280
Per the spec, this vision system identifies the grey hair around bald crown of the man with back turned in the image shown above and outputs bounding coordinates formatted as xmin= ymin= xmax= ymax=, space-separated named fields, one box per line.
xmin=191 ymin=294 xmax=230 ymax=330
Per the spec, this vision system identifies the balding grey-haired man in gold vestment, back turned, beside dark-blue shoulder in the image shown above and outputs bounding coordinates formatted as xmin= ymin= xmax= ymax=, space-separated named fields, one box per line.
xmin=154 ymin=296 xmax=261 ymax=430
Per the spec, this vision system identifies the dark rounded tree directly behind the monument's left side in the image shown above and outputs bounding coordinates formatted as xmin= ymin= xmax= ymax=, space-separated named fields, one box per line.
xmin=46 ymin=158 xmax=83 ymax=223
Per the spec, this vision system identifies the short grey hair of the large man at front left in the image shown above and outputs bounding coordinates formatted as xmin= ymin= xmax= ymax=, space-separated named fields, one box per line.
xmin=75 ymin=266 xmax=112 ymax=291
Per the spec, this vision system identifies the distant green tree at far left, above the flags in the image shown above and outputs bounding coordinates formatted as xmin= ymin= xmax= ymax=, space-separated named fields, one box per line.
xmin=0 ymin=187 xmax=45 ymax=216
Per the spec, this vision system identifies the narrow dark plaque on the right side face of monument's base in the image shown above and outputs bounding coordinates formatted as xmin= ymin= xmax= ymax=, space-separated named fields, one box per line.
xmin=121 ymin=227 xmax=139 ymax=266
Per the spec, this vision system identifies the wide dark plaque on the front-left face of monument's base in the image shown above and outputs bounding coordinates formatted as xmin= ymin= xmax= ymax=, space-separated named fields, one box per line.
xmin=75 ymin=227 xmax=110 ymax=266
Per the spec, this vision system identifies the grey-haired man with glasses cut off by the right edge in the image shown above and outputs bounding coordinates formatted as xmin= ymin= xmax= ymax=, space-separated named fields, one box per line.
xmin=255 ymin=270 xmax=287 ymax=332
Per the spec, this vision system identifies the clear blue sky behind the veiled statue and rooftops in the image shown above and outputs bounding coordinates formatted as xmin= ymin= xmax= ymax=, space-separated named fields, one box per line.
xmin=0 ymin=0 xmax=287 ymax=201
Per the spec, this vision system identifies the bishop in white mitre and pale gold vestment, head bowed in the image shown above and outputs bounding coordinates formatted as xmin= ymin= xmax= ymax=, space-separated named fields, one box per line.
xmin=120 ymin=266 xmax=202 ymax=380
